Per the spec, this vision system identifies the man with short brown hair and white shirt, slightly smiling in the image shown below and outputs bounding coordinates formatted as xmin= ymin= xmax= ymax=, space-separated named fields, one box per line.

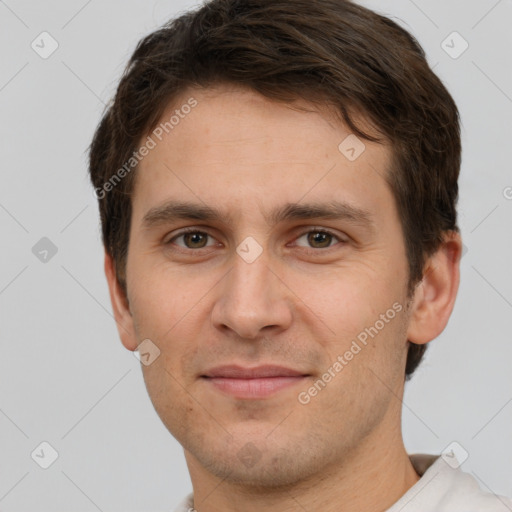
xmin=90 ymin=0 xmax=512 ymax=512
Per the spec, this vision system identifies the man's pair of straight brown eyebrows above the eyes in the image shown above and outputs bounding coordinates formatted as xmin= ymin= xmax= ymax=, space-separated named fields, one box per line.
xmin=142 ymin=200 xmax=375 ymax=231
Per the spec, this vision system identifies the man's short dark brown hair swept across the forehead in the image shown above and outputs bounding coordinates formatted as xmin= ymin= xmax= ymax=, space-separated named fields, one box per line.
xmin=89 ymin=0 xmax=461 ymax=378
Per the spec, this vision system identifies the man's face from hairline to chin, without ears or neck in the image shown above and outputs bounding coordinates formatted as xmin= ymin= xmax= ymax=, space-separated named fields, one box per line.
xmin=122 ymin=86 xmax=416 ymax=486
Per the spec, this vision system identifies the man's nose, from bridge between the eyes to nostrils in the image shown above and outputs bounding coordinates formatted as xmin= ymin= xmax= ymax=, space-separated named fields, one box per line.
xmin=211 ymin=251 xmax=293 ymax=340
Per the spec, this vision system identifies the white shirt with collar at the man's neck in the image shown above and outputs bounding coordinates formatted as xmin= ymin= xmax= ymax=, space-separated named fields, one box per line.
xmin=174 ymin=454 xmax=512 ymax=512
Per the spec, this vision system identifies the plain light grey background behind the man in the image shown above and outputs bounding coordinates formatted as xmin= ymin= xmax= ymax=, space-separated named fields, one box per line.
xmin=0 ymin=0 xmax=512 ymax=512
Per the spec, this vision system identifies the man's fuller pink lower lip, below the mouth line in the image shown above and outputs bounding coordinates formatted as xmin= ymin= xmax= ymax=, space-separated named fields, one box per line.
xmin=205 ymin=376 xmax=305 ymax=399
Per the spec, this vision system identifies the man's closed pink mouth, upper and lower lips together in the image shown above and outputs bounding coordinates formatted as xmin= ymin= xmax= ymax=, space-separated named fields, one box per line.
xmin=201 ymin=365 xmax=310 ymax=400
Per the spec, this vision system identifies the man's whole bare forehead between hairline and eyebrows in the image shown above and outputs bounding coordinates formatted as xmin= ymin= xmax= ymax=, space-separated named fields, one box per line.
xmin=134 ymin=85 xmax=396 ymax=224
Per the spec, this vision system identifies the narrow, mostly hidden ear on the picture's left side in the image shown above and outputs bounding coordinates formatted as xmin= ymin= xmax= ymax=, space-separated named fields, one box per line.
xmin=105 ymin=251 xmax=138 ymax=351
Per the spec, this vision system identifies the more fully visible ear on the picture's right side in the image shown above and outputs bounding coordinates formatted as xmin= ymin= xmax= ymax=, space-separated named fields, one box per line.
xmin=407 ymin=231 xmax=462 ymax=345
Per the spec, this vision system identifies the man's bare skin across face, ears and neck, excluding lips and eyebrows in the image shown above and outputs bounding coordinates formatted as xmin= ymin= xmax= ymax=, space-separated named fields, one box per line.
xmin=105 ymin=85 xmax=461 ymax=512
